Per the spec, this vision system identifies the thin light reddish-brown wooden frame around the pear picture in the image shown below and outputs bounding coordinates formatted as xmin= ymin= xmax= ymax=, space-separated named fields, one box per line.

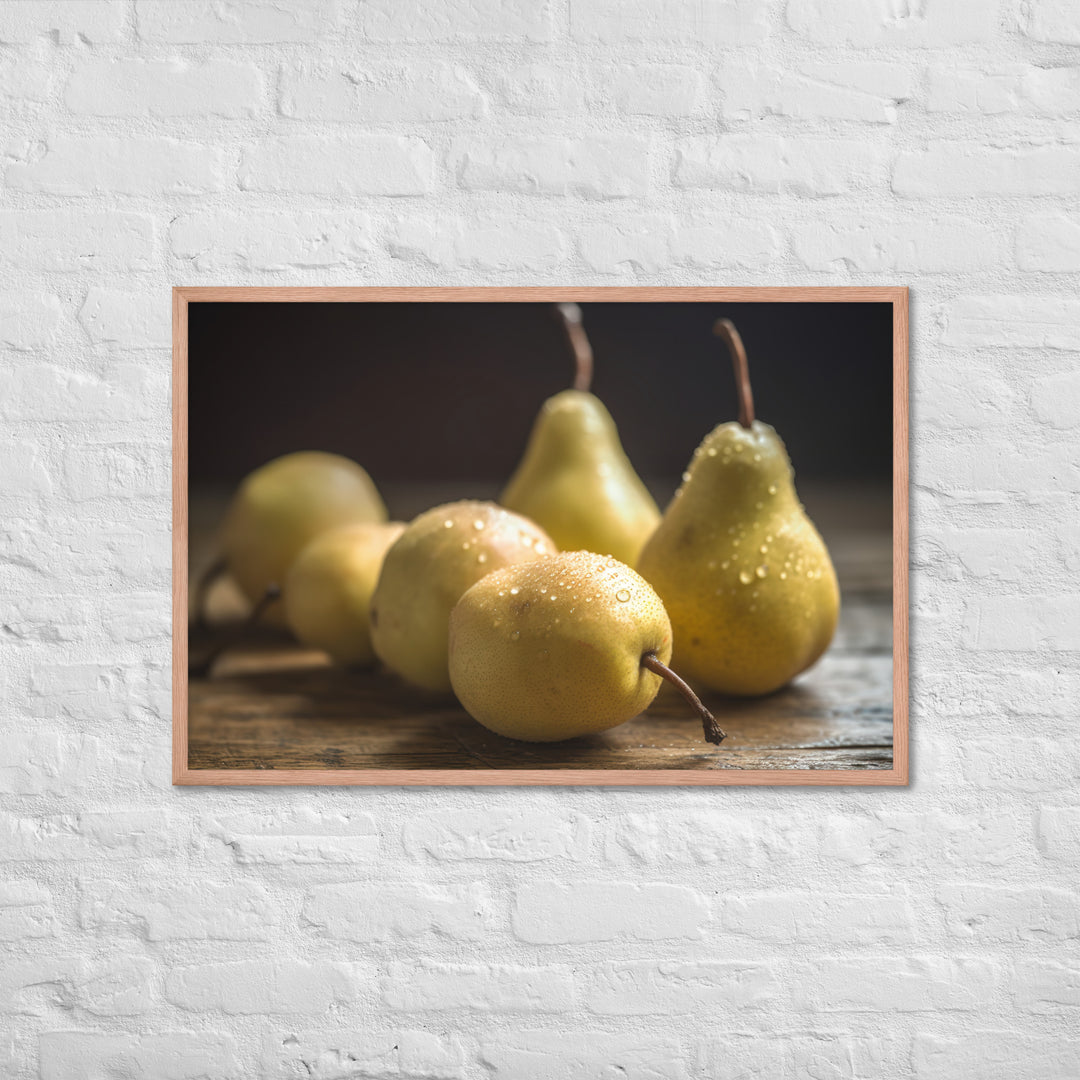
xmin=173 ymin=286 xmax=908 ymax=787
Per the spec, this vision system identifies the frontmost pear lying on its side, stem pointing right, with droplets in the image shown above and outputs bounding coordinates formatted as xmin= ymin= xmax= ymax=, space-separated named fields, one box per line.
xmin=450 ymin=551 xmax=724 ymax=743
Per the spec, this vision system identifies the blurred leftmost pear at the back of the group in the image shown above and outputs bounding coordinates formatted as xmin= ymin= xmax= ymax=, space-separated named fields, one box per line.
xmin=222 ymin=450 xmax=387 ymax=623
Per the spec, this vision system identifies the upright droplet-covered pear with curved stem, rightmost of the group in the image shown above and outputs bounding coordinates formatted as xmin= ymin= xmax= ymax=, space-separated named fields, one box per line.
xmin=637 ymin=320 xmax=840 ymax=696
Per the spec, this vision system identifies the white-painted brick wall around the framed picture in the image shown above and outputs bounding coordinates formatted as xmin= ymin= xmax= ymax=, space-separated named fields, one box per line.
xmin=0 ymin=0 xmax=1080 ymax=1080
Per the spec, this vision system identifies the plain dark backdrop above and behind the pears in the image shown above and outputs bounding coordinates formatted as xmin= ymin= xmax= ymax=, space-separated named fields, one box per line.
xmin=189 ymin=303 xmax=892 ymax=494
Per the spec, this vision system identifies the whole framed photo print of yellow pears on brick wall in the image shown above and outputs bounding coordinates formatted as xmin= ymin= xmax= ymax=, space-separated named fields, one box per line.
xmin=173 ymin=287 xmax=908 ymax=785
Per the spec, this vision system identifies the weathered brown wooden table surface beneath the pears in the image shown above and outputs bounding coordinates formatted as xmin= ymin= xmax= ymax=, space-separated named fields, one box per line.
xmin=188 ymin=488 xmax=892 ymax=769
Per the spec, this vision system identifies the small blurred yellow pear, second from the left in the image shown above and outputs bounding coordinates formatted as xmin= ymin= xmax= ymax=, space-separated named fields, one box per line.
xmin=283 ymin=522 xmax=405 ymax=665
